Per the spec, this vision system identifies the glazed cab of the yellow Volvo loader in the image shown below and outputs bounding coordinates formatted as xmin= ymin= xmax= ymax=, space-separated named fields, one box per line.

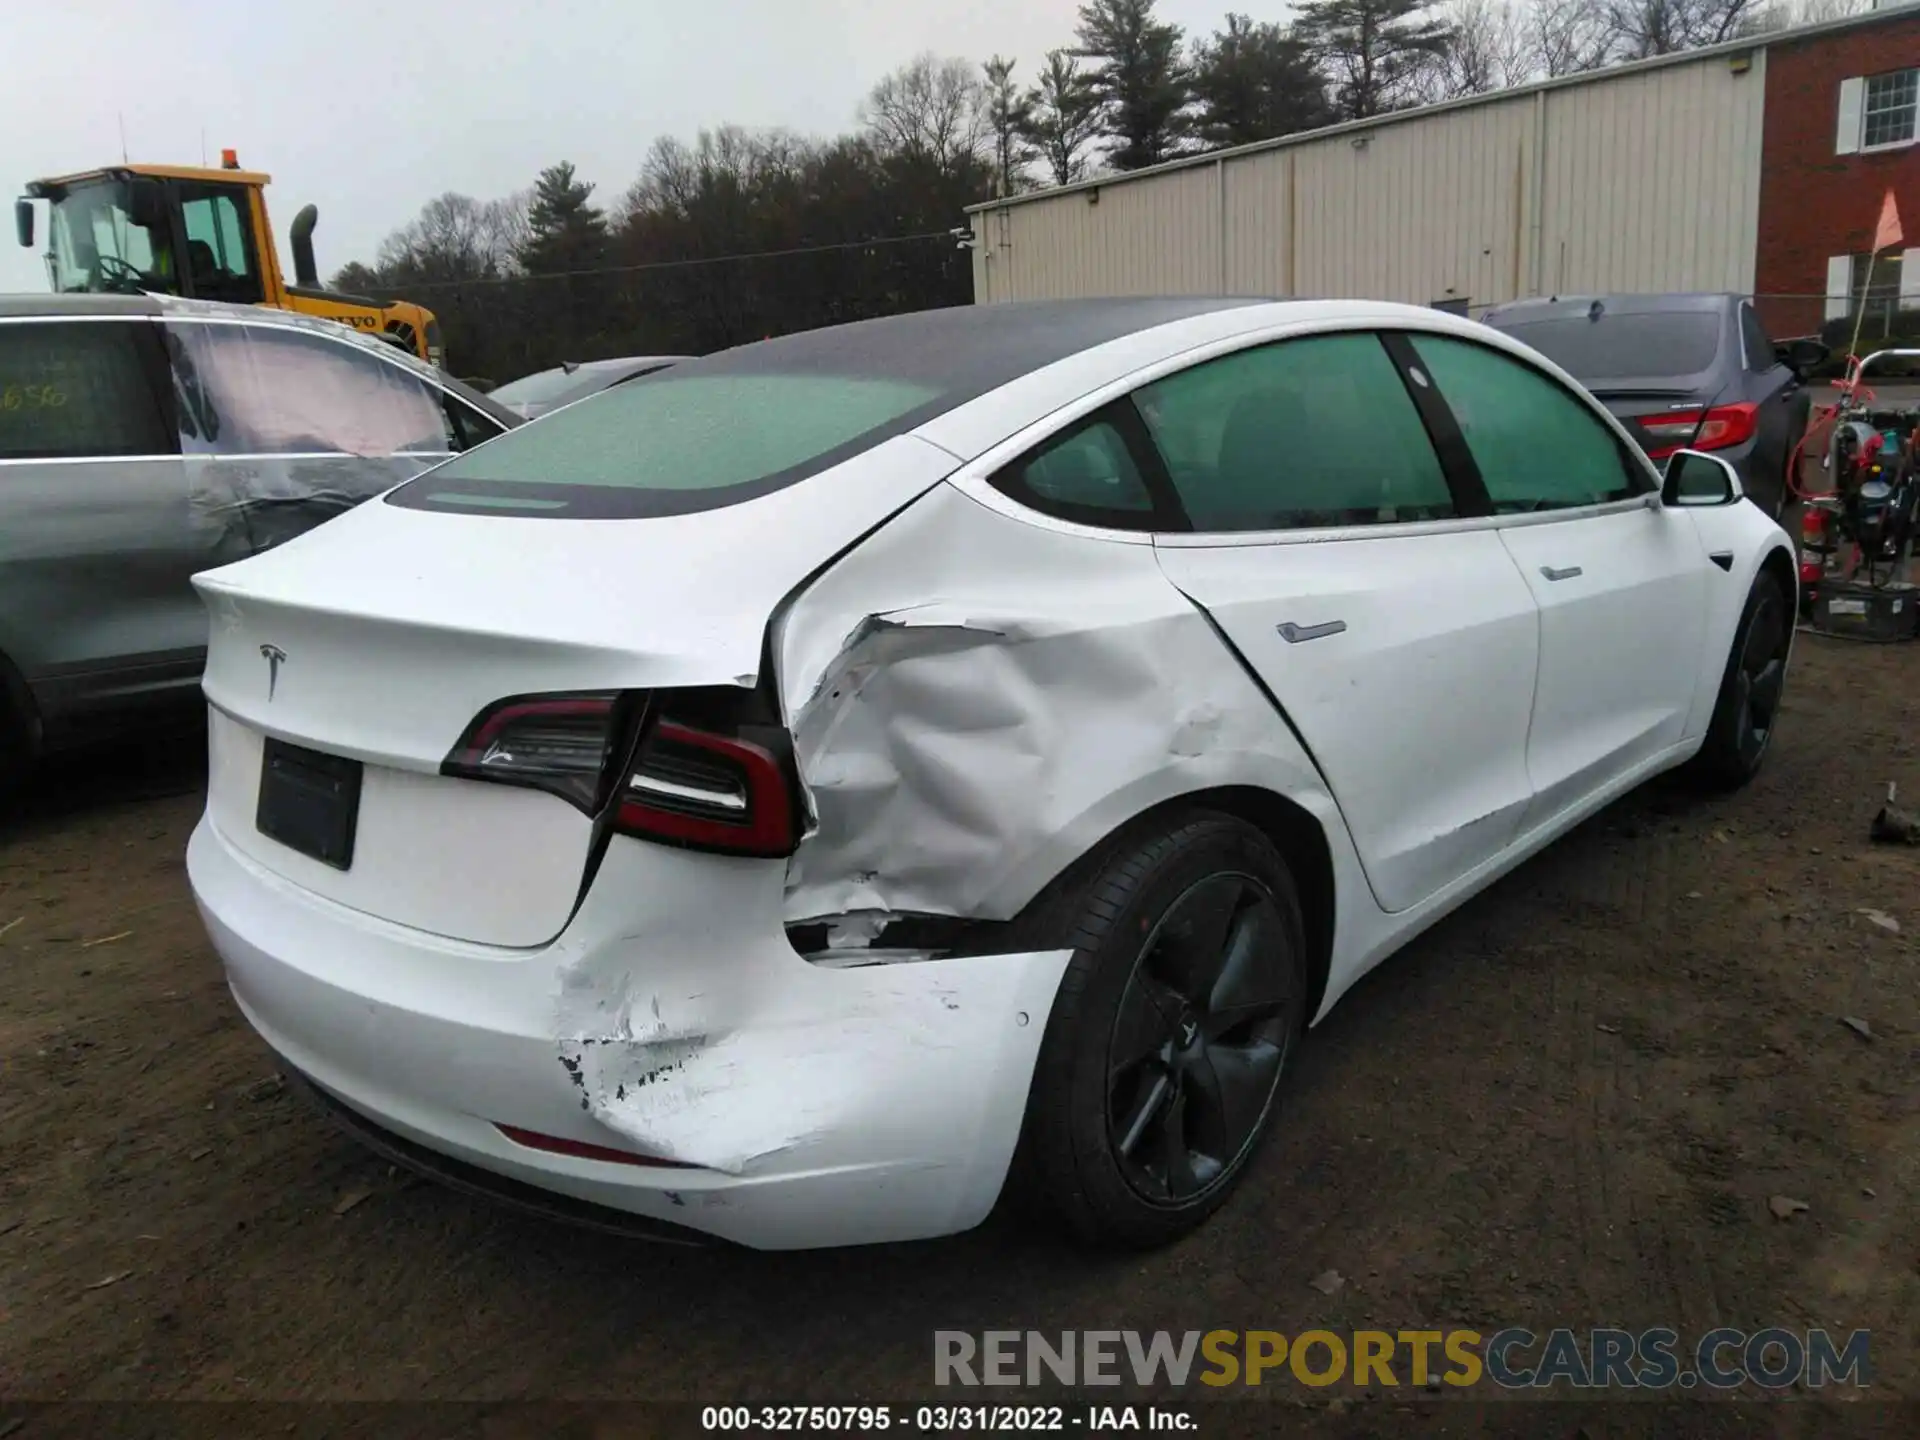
xmin=21 ymin=167 xmax=284 ymax=305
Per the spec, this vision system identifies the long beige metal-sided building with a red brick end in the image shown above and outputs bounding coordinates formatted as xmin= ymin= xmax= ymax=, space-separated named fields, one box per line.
xmin=968 ymin=0 xmax=1920 ymax=347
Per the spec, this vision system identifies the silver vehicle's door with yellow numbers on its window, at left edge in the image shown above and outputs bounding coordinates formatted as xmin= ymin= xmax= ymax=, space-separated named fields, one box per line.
xmin=0 ymin=319 xmax=207 ymax=718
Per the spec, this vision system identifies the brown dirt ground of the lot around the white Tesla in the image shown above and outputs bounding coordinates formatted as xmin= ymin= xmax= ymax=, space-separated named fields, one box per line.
xmin=0 ymin=639 xmax=1920 ymax=1440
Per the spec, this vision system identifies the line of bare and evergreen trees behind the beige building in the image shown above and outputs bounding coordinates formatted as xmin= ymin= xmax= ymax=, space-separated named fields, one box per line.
xmin=334 ymin=0 xmax=1870 ymax=382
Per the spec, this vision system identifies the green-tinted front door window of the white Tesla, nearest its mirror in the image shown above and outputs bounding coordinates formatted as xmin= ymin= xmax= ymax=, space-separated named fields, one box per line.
xmin=1411 ymin=334 xmax=1651 ymax=515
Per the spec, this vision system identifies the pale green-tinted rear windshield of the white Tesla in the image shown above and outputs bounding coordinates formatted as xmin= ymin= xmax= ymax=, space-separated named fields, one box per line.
xmin=388 ymin=372 xmax=943 ymax=518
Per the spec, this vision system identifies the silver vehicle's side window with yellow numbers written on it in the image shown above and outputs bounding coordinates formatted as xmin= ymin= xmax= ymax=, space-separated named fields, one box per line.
xmin=0 ymin=321 xmax=179 ymax=461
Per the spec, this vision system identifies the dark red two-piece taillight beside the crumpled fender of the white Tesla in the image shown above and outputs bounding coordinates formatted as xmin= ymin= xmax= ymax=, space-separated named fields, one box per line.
xmin=440 ymin=687 xmax=801 ymax=856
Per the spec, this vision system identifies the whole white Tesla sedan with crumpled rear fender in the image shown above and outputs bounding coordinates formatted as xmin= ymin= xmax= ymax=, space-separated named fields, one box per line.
xmin=188 ymin=300 xmax=1795 ymax=1248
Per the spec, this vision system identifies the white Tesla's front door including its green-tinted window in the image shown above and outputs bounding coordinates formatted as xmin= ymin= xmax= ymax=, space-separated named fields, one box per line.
xmin=1411 ymin=334 xmax=1716 ymax=828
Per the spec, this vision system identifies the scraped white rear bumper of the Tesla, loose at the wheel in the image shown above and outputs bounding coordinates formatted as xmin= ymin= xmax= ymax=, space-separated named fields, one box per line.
xmin=186 ymin=818 xmax=1068 ymax=1248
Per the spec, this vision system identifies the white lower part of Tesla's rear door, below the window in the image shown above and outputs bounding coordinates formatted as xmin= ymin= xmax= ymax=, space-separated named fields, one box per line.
xmin=1158 ymin=528 xmax=1540 ymax=910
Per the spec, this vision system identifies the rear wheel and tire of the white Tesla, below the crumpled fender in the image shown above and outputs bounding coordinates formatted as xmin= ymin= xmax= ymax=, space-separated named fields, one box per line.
xmin=1016 ymin=810 xmax=1308 ymax=1248
